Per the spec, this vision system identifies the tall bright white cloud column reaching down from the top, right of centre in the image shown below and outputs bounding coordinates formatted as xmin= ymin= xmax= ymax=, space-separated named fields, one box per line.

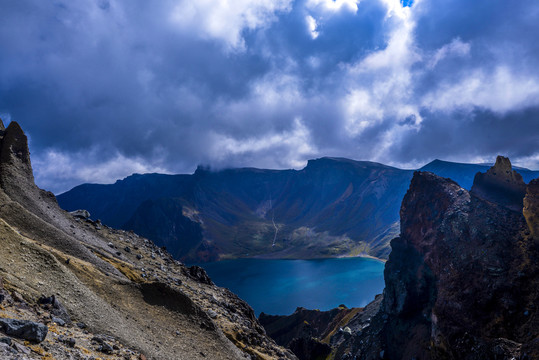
xmin=342 ymin=0 xmax=421 ymax=136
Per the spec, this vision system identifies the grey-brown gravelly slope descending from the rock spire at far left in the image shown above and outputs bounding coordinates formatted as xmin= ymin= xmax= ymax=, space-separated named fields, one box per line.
xmin=0 ymin=122 xmax=294 ymax=359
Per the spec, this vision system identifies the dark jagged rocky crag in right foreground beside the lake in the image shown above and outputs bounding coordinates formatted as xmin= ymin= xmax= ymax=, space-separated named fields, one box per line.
xmin=334 ymin=157 xmax=539 ymax=360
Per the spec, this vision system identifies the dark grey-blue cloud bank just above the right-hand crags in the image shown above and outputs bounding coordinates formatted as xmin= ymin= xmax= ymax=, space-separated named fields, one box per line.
xmin=393 ymin=107 xmax=539 ymax=161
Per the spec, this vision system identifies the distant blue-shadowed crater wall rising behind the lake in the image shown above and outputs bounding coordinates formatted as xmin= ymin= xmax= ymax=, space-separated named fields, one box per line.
xmin=57 ymin=158 xmax=539 ymax=262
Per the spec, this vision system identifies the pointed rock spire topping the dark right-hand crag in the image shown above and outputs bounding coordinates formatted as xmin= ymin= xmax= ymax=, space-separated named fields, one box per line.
xmin=471 ymin=155 xmax=526 ymax=212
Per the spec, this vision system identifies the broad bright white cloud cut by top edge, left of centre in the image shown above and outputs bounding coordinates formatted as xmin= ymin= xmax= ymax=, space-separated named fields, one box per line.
xmin=171 ymin=0 xmax=292 ymax=50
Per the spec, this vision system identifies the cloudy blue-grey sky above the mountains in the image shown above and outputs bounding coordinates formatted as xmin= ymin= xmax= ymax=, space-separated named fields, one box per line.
xmin=0 ymin=0 xmax=539 ymax=193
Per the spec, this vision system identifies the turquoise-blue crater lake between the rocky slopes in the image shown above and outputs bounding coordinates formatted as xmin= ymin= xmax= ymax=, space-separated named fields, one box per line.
xmin=196 ymin=258 xmax=384 ymax=316
